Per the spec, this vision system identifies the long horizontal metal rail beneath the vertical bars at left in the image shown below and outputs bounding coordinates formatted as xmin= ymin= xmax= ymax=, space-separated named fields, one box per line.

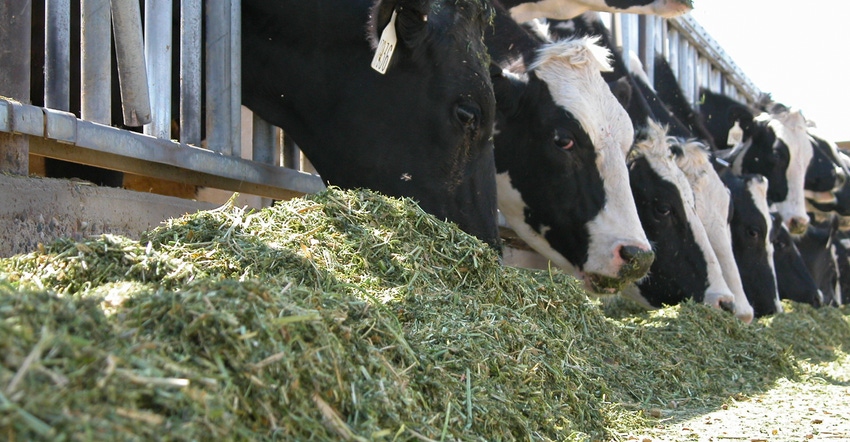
xmin=0 ymin=99 xmax=325 ymax=199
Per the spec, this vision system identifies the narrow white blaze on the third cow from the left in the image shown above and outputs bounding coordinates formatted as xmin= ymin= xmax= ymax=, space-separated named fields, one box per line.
xmin=635 ymin=120 xmax=735 ymax=307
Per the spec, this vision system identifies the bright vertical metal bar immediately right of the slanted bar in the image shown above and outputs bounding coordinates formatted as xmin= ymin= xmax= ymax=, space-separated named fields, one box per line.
xmin=144 ymin=0 xmax=172 ymax=140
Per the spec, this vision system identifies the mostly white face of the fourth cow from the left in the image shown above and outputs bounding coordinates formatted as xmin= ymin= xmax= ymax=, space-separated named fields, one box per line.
xmin=676 ymin=141 xmax=752 ymax=323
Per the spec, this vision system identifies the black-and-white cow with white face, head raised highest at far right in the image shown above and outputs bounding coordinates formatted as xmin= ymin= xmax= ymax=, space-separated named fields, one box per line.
xmin=699 ymin=88 xmax=814 ymax=234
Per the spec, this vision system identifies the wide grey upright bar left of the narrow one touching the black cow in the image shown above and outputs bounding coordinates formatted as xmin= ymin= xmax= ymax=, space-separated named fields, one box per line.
xmin=204 ymin=0 xmax=234 ymax=155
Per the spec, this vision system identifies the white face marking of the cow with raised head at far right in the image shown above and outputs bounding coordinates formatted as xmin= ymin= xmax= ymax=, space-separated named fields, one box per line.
xmin=756 ymin=110 xmax=814 ymax=228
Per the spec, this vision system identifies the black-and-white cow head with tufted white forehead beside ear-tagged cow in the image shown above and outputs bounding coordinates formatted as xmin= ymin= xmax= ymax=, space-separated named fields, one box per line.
xmin=485 ymin=5 xmax=654 ymax=293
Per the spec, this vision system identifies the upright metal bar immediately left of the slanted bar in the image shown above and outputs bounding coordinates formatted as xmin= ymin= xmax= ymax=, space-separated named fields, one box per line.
xmin=80 ymin=0 xmax=112 ymax=124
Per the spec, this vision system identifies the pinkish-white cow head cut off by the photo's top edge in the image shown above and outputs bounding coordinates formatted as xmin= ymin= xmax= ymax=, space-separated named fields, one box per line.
xmin=501 ymin=0 xmax=694 ymax=23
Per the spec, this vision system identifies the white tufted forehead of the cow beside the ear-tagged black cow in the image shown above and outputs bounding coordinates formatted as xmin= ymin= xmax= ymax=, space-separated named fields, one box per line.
xmin=531 ymin=37 xmax=634 ymax=154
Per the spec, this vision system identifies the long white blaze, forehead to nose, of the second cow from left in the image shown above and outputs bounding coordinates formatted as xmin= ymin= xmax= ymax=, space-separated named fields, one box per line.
xmin=531 ymin=38 xmax=650 ymax=276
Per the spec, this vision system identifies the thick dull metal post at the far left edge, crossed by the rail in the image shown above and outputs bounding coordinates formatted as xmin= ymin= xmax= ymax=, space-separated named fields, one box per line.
xmin=0 ymin=0 xmax=32 ymax=175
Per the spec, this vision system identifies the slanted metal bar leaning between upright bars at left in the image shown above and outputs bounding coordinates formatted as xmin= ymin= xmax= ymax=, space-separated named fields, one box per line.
xmin=110 ymin=0 xmax=151 ymax=127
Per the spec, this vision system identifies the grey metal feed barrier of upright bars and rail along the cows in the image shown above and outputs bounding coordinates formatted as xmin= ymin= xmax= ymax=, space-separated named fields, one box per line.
xmin=0 ymin=0 xmax=759 ymax=199
